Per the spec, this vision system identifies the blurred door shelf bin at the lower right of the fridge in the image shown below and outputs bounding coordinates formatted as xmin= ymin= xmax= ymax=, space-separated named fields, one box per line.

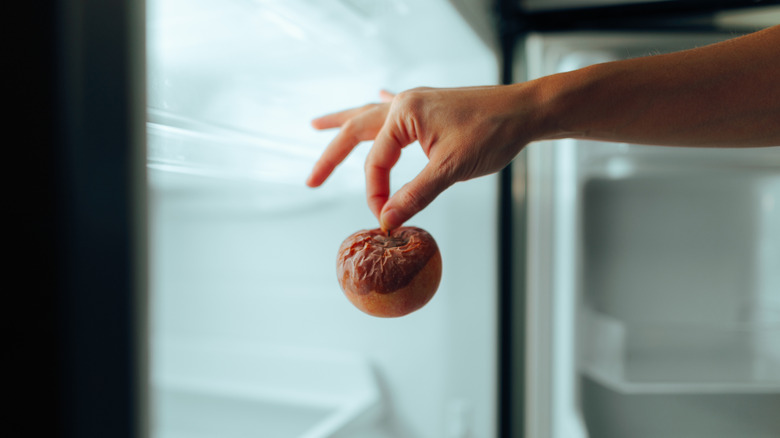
xmin=581 ymin=310 xmax=780 ymax=393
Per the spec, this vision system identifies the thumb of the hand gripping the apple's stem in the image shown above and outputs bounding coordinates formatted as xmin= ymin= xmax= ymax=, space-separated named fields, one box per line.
xmin=379 ymin=162 xmax=452 ymax=230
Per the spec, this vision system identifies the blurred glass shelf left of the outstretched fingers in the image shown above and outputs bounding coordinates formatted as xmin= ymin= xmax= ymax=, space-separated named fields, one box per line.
xmin=147 ymin=109 xmax=363 ymax=215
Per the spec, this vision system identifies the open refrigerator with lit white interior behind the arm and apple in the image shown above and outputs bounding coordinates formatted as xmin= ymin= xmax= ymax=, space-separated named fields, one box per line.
xmin=35 ymin=0 xmax=780 ymax=438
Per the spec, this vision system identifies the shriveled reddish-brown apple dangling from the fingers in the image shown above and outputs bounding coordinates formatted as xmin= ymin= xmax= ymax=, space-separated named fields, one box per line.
xmin=336 ymin=227 xmax=441 ymax=318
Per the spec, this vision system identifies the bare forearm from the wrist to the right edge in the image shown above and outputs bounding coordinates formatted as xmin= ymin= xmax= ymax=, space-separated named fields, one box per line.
xmin=534 ymin=26 xmax=780 ymax=147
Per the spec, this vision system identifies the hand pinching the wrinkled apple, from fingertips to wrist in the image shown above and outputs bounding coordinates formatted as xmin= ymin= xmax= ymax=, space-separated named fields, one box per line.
xmin=307 ymin=84 xmax=536 ymax=230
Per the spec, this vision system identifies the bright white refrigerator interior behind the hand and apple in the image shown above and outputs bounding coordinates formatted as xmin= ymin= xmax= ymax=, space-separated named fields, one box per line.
xmin=147 ymin=0 xmax=498 ymax=438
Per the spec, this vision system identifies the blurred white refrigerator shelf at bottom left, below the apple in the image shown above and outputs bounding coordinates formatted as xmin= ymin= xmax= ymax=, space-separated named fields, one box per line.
xmin=152 ymin=339 xmax=381 ymax=438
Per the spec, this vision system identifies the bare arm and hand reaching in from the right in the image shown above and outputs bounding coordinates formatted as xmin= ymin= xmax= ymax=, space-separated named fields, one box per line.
xmin=306 ymin=26 xmax=780 ymax=230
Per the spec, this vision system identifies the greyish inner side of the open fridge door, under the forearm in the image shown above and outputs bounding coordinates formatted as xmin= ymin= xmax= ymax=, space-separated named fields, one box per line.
xmin=516 ymin=32 xmax=780 ymax=438
